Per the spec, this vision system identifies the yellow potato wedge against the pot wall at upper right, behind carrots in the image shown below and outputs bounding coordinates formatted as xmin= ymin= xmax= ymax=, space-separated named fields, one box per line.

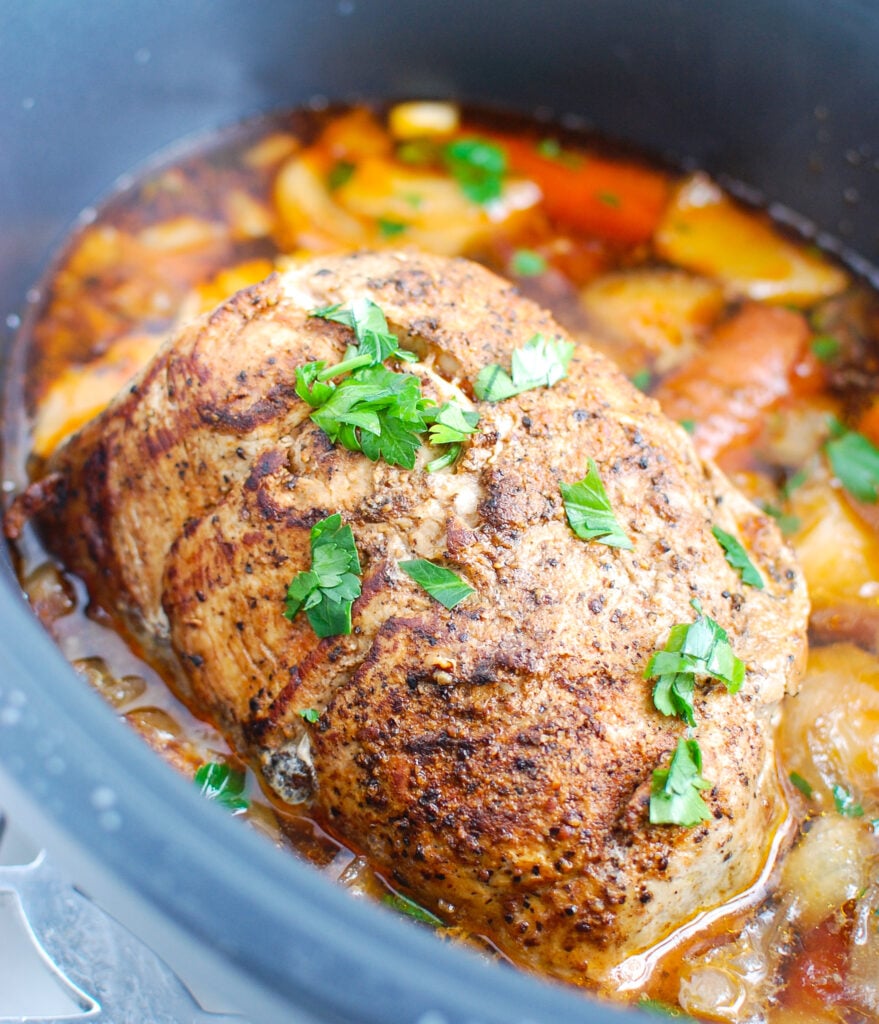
xmin=655 ymin=174 xmax=848 ymax=305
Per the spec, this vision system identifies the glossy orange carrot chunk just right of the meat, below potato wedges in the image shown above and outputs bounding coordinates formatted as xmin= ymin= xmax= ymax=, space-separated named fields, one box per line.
xmin=654 ymin=303 xmax=820 ymax=458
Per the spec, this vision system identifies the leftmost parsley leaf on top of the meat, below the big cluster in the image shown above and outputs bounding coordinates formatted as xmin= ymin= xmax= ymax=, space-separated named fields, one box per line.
xmin=284 ymin=512 xmax=361 ymax=638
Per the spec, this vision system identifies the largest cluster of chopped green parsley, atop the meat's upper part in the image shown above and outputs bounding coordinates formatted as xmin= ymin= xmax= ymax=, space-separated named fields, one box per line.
xmin=296 ymin=299 xmax=478 ymax=470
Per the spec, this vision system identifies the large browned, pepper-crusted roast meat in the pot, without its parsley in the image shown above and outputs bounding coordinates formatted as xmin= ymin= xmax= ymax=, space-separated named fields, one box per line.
xmin=7 ymin=253 xmax=807 ymax=986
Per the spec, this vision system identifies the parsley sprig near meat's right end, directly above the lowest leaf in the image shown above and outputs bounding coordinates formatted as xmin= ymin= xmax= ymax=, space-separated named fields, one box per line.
xmin=644 ymin=601 xmax=745 ymax=727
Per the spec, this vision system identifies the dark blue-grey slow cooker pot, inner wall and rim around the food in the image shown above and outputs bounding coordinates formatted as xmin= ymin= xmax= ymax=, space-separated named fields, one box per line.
xmin=0 ymin=0 xmax=879 ymax=1024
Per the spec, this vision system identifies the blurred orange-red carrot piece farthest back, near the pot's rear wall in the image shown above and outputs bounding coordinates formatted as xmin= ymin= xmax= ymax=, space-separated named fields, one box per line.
xmin=495 ymin=135 xmax=671 ymax=245
